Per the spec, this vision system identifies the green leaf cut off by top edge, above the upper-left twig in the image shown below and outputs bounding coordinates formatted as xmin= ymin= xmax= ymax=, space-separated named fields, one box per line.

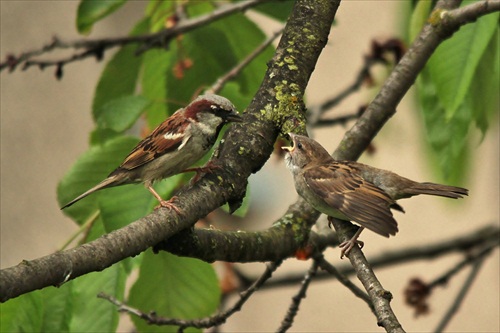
xmin=76 ymin=0 xmax=127 ymax=35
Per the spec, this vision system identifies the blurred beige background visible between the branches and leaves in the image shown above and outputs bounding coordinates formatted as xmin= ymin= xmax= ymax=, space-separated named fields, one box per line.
xmin=0 ymin=1 xmax=500 ymax=332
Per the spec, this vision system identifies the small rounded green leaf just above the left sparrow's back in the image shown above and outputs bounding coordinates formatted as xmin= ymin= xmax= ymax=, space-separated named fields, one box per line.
xmin=96 ymin=96 xmax=150 ymax=132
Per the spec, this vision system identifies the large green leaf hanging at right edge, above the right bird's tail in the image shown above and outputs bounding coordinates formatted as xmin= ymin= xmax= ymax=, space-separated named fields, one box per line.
xmin=417 ymin=7 xmax=499 ymax=184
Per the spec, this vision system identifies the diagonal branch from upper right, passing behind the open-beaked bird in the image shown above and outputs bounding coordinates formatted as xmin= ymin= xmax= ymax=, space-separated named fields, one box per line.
xmin=324 ymin=1 xmax=494 ymax=332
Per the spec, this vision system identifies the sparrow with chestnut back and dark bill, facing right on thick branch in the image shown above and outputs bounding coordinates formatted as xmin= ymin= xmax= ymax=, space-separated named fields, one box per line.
xmin=61 ymin=94 xmax=242 ymax=213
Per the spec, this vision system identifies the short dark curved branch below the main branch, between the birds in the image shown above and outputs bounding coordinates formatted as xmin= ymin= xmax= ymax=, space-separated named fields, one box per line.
xmin=154 ymin=196 xmax=322 ymax=262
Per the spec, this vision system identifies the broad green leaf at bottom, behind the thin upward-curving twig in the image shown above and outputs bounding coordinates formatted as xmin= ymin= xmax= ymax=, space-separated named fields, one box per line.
xmin=128 ymin=250 xmax=220 ymax=332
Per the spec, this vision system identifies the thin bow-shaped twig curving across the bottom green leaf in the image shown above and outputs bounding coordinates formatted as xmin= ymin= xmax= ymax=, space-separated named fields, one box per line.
xmin=97 ymin=260 xmax=283 ymax=331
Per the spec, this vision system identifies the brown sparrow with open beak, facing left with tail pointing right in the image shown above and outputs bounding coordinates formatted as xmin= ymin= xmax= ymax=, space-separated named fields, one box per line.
xmin=282 ymin=133 xmax=468 ymax=258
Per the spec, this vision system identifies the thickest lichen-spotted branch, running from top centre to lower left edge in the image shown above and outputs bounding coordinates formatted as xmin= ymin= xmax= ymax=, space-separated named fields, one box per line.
xmin=0 ymin=0 xmax=338 ymax=302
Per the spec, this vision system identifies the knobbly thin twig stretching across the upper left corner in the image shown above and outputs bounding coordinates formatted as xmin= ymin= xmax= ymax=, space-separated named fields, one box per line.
xmin=0 ymin=0 xmax=266 ymax=71
